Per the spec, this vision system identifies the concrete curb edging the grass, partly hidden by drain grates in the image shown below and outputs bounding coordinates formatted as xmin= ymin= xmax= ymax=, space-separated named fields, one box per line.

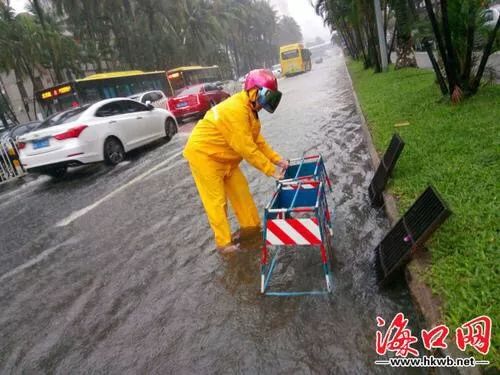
xmin=345 ymin=60 xmax=482 ymax=375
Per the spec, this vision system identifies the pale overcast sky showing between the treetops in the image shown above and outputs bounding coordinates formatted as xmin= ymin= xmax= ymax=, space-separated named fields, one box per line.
xmin=10 ymin=0 xmax=330 ymax=41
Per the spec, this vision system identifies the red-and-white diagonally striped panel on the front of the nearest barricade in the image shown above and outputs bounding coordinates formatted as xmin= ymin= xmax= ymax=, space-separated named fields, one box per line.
xmin=266 ymin=218 xmax=322 ymax=245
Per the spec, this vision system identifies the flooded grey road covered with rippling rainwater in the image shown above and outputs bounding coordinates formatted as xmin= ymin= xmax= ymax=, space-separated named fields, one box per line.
xmin=0 ymin=51 xmax=418 ymax=374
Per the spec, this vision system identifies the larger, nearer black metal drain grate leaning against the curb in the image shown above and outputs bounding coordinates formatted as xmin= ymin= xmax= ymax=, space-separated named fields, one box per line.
xmin=375 ymin=186 xmax=451 ymax=285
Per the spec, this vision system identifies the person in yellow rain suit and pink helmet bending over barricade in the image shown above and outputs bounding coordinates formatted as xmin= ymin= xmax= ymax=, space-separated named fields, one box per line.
xmin=183 ymin=69 xmax=288 ymax=253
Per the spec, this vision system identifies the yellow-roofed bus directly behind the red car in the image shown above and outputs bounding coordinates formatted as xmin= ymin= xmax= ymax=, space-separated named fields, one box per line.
xmin=167 ymin=65 xmax=222 ymax=92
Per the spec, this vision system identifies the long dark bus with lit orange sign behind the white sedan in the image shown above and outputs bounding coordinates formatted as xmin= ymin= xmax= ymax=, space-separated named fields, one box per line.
xmin=36 ymin=70 xmax=172 ymax=117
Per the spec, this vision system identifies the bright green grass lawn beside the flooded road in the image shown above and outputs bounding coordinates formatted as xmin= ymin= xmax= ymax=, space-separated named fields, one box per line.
xmin=348 ymin=62 xmax=500 ymax=367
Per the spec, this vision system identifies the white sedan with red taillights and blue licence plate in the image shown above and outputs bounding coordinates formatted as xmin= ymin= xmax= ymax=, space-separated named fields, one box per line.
xmin=18 ymin=98 xmax=178 ymax=177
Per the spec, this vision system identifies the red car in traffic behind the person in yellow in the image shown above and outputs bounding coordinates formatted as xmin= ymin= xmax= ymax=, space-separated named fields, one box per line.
xmin=167 ymin=83 xmax=230 ymax=122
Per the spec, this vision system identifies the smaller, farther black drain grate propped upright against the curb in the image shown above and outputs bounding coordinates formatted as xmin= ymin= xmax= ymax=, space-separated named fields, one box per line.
xmin=368 ymin=134 xmax=405 ymax=207
